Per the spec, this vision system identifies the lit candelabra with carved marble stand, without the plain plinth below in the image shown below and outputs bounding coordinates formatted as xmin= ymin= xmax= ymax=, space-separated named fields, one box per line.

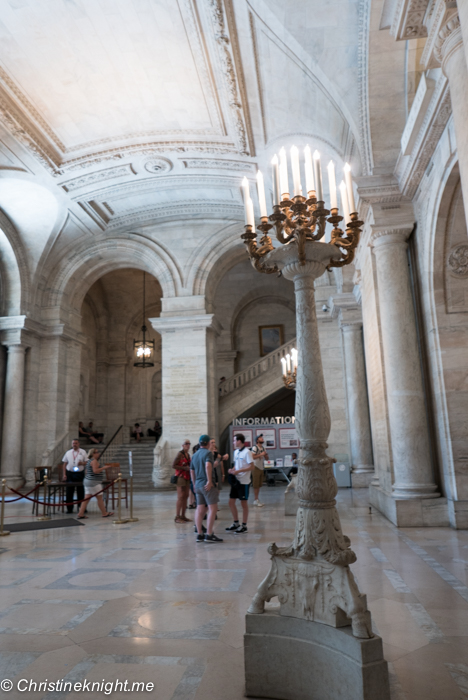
xmin=242 ymin=147 xmax=373 ymax=640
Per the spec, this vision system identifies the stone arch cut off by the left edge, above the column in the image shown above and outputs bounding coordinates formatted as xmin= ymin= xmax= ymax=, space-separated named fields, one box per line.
xmin=0 ymin=210 xmax=30 ymax=316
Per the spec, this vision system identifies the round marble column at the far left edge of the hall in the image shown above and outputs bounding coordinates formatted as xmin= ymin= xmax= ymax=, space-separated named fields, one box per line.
xmin=1 ymin=344 xmax=26 ymax=489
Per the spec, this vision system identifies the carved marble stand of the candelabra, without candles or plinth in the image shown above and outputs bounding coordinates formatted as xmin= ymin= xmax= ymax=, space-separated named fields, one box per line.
xmin=245 ymin=241 xmax=373 ymax=638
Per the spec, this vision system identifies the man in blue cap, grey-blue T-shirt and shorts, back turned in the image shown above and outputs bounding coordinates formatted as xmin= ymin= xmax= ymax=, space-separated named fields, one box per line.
xmin=190 ymin=435 xmax=223 ymax=542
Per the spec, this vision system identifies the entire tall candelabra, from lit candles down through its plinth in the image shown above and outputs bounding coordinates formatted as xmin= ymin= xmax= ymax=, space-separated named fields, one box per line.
xmin=242 ymin=147 xmax=390 ymax=700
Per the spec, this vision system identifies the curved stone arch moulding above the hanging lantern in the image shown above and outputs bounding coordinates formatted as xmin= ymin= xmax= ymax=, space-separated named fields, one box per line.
xmin=42 ymin=234 xmax=181 ymax=322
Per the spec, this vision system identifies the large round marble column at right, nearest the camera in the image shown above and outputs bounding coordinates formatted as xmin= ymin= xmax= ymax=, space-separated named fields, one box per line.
xmin=372 ymin=232 xmax=439 ymax=500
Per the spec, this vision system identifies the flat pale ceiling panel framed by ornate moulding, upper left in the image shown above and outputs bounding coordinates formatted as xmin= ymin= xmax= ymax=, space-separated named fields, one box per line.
xmin=0 ymin=0 xmax=224 ymax=152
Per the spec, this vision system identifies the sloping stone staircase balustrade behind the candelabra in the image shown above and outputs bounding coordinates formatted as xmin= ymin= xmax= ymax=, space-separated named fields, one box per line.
xmin=218 ymin=338 xmax=296 ymax=432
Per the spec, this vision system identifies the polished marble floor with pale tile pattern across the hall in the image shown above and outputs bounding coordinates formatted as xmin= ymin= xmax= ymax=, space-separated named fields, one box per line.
xmin=0 ymin=486 xmax=468 ymax=700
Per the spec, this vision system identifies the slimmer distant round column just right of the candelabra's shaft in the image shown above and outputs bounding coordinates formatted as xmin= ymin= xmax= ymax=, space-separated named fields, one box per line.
xmin=340 ymin=320 xmax=374 ymax=488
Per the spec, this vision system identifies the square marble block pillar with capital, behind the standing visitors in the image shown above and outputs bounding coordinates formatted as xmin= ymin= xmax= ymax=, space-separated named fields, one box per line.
xmin=150 ymin=313 xmax=220 ymax=487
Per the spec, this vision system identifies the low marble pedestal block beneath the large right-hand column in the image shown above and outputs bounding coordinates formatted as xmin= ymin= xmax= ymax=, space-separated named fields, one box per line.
xmin=369 ymin=484 xmax=450 ymax=527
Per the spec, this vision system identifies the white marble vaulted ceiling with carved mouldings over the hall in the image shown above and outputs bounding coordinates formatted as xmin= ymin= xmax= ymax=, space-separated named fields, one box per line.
xmin=0 ymin=0 xmax=372 ymax=318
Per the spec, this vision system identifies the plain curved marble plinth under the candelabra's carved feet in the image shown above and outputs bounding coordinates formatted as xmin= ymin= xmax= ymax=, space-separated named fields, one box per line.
xmin=244 ymin=610 xmax=390 ymax=700
